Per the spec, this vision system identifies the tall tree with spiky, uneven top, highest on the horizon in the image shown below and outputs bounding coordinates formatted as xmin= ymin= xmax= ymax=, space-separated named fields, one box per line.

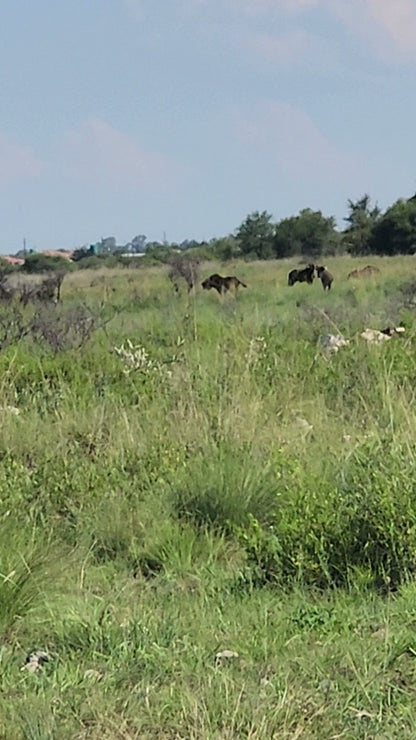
xmin=342 ymin=193 xmax=381 ymax=255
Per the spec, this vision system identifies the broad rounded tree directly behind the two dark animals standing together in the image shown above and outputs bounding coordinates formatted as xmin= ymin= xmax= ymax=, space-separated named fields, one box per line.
xmin=274 ymin=208 xmax=340 ymax=258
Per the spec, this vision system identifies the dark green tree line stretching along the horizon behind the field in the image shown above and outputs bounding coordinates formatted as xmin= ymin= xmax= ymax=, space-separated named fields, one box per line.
xmin=8 ymin=194 xmax=416 ymax=272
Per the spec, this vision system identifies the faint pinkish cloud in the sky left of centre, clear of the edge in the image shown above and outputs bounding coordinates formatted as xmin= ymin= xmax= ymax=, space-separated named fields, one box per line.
xmin=63 ymin=118 xmax=179 ymax=190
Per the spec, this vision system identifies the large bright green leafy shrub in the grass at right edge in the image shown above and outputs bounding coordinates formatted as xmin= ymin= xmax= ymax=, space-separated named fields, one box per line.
xmin=234 ymin=444 xmax=416 ymax=588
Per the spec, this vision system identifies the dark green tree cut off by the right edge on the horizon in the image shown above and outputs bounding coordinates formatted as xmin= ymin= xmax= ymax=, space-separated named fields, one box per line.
xmin=370 ymin=197 xmax=416 ymax=255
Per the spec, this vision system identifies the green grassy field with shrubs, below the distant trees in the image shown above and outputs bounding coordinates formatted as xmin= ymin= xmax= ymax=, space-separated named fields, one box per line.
xmin=0 ymin=257 xmax=416 ymax=740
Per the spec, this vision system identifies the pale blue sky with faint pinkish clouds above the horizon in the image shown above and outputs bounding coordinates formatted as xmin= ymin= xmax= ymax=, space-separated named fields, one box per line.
xmin=0 ymin=0 xmax=416 ymax=254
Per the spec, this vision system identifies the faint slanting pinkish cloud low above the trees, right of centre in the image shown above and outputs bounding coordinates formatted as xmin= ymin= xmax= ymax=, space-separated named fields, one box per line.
xmin=235 ymin=102 xmax=356 ymax=184
